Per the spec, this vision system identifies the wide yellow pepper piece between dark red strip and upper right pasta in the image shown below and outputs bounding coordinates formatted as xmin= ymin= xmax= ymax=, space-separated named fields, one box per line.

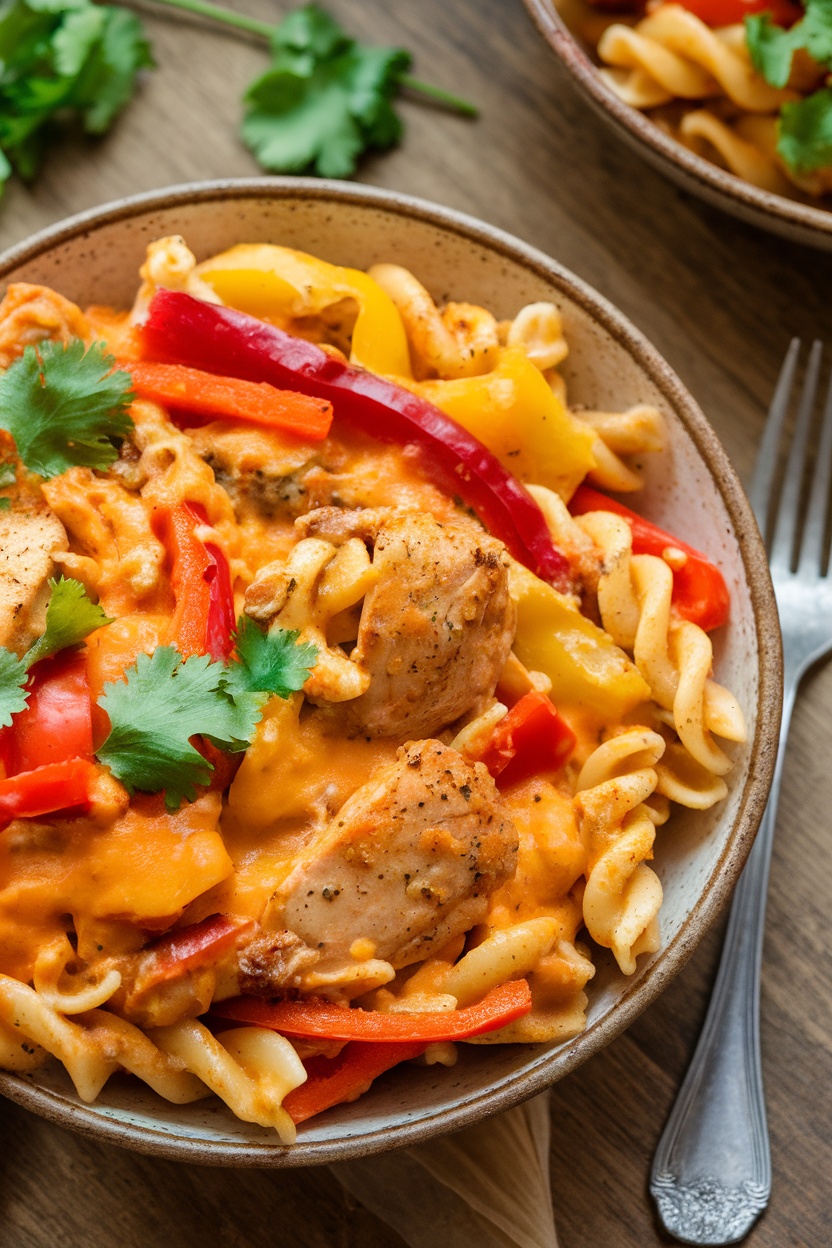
xmin=414 ymin=347 xmax=595 ymax=502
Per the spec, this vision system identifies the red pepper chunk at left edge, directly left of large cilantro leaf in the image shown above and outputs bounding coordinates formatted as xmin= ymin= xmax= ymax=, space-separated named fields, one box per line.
xmin=0 ymin=650 xmax=92 ymax=776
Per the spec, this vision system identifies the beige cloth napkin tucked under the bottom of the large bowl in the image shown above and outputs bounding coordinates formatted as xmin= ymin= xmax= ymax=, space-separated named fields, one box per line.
xmin=331 ymin=1093 xmax=558 ymax=1248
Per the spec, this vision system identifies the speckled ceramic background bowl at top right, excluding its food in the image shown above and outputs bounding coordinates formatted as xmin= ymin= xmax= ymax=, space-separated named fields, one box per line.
xmin=524 ymin=0 xmax=832 ymax=251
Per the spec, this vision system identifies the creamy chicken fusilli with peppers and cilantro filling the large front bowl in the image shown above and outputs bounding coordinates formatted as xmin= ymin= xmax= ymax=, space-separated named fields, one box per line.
xmin=0 ymin=237 xmax=745 ymax=1143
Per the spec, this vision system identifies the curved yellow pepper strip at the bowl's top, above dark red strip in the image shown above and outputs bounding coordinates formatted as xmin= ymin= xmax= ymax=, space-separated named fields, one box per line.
xmin=197 ymin=243 xmax=412 ymax=377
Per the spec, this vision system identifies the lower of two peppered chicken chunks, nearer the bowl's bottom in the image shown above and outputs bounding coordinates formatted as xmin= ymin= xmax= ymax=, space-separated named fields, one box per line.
xmin=263 ymin=741 xmax=518 ymax=995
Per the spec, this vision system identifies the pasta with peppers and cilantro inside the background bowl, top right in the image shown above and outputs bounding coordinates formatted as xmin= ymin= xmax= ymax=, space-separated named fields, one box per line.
xmin=563 ymin=0 xmax=832 ymax=201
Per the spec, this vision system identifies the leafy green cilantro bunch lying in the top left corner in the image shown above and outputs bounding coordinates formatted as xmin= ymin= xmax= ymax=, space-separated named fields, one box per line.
xmin=0 ymin=0 xmax=153 ymax=186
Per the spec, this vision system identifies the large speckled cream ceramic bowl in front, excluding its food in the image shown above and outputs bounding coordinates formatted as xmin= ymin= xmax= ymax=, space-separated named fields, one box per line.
xmin=0 ymin=178 xmax=780 ymax=1166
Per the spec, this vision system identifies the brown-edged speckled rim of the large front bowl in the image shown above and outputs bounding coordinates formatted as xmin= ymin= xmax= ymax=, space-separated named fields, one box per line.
xmin=0 ymin=178 xmax=782 ymax=1167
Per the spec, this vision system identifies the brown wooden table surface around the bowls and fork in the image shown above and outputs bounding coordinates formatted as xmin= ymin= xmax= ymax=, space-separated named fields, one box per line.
xmin=0 ymin=0 xmax=832 ymax=1248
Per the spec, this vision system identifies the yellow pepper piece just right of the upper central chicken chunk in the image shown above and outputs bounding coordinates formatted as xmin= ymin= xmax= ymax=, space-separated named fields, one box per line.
xmin=511 ymin=564 xmax=650 ymax=720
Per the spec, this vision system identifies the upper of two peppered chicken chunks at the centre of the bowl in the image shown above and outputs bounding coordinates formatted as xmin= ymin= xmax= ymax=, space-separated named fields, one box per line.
xmin=338 ymin=512 xmax=515 ymax=738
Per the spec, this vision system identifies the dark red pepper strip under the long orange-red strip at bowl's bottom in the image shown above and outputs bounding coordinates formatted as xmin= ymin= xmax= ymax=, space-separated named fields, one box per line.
xmin=283 ymin=1041 xmax=428 ymax=1123
